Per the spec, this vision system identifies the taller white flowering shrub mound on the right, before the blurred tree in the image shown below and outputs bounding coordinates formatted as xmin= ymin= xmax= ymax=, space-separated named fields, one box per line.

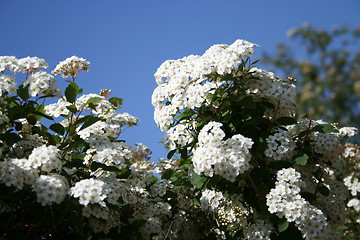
xmin=152 ymin=40 xmax=359 ymax=240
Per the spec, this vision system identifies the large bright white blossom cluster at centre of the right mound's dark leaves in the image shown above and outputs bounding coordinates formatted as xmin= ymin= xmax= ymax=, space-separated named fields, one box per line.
xmin=192 ymin=122 xmax=253 ymax=182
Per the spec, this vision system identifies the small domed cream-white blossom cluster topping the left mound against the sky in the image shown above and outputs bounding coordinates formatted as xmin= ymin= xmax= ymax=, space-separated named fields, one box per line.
xmin=52 ymin=56 xmax=90 ymax=78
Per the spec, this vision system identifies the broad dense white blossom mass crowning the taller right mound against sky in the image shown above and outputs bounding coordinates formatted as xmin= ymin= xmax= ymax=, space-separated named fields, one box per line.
xmin=152 ymin=40 xmax=256 ymax=131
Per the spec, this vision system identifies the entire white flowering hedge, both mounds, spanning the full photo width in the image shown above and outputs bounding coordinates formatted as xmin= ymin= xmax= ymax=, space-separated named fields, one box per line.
xmin=0 ymin=40 xmax=360 ymax=240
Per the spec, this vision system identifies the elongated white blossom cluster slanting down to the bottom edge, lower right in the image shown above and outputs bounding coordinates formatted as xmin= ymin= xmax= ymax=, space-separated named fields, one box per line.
xmin=266 ymin=168 xmax=336 ymax=239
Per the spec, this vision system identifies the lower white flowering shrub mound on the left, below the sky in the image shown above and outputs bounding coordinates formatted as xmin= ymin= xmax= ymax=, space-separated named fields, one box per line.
xmin=0 ymin=56 xmax=172 ymax=239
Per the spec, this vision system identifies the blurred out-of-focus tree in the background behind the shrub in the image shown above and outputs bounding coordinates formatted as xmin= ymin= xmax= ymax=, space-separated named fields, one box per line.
xmin=263 ymin=24 xmax=360 ymax=143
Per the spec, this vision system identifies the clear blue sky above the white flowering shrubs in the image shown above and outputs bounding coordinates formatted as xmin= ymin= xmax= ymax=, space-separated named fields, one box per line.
xmin=0 ymin=0 xmax=360 ymax=160
